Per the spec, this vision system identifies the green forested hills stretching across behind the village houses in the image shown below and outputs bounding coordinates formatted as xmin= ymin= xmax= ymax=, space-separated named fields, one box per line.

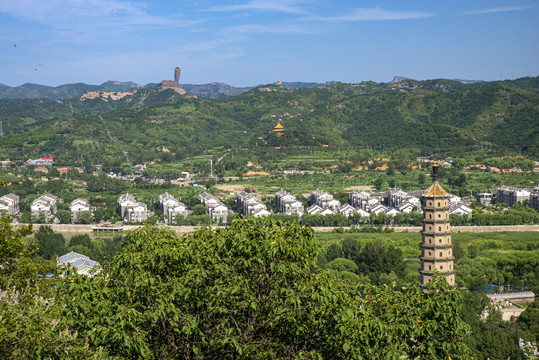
xmin=0 ymin=78 xmax=539 ymax=165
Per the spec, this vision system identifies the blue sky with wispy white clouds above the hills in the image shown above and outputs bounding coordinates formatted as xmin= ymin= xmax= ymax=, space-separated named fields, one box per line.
xmin=0 ymin=0 xmax=539 ymax=86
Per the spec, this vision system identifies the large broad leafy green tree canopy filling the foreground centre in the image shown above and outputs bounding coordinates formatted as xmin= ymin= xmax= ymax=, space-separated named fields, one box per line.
xmin=0 ymin=215 xmax=469 ymax=359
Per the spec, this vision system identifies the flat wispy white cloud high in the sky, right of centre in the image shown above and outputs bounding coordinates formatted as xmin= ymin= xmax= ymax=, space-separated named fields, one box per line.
xmin=308 ymin=8 xmax=434 ymax=22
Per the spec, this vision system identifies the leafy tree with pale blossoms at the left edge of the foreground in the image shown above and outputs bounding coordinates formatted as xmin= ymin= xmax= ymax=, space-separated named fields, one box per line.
xmin=0 ymin=214 xmax=96 ymax=359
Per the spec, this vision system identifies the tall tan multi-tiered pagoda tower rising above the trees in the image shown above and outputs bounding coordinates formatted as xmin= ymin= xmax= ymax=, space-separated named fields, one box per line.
xmin=419 ymin=164 xmax=455 ymax=288
